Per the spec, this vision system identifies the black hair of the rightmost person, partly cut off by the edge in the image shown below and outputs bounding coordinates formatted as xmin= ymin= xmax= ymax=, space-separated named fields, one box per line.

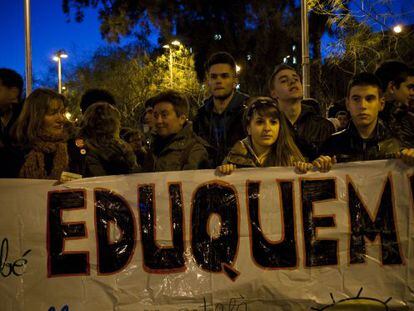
xmin=375 ymin=60 xmax=411 ymax=92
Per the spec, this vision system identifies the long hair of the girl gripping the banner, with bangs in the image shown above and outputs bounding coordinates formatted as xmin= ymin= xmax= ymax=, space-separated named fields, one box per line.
xmin=243 ymin=97 xmax=305 ymax=166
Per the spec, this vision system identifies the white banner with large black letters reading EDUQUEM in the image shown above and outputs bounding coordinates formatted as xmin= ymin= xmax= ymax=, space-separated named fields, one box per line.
xmin=0 ymin=160 xmax=414 ymax=311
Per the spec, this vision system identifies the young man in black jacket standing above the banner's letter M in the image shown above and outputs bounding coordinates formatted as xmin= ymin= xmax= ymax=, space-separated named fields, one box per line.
xmin=321 ymin=73 xmax=414 ymax=165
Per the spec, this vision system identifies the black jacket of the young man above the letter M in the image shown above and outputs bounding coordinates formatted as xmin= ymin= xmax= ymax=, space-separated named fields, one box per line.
xmin=321 ymin=120 xmax=401 ymax=162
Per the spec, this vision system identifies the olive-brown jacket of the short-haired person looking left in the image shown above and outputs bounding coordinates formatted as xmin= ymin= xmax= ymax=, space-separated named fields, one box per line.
xmin=144 ymin=124 xmax=211 ymax=172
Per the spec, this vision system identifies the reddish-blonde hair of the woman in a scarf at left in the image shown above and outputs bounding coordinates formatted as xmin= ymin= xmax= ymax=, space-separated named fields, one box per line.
xmin=12 ymin=88 xmax=65 ymax=147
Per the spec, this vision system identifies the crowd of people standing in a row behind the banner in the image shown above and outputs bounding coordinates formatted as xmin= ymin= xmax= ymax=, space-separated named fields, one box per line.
xmin=0 ymin=52 xmax=414 ymax=181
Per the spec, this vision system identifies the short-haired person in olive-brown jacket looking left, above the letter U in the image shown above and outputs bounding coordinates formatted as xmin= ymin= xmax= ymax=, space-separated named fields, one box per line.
xmin=144 ymin=91 xmax=210 ymax=172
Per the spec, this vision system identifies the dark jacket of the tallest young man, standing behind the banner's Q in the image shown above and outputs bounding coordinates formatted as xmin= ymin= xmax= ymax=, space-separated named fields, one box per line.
xmin=193 ymin=91 xmax=248 ymax=166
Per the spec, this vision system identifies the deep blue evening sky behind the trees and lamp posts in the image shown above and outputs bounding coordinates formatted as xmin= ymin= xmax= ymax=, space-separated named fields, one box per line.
xmin=0 ymin=0 xmax=414 ymax=84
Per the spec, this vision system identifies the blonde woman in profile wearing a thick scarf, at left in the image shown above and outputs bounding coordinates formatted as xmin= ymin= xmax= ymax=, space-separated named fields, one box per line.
xmin=10 ymin=89 xmax=69 ymax=179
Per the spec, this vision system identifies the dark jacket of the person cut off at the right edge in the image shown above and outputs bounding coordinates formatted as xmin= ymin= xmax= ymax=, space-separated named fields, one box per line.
xmin=380 ymin=101 xmax=414 ymax=148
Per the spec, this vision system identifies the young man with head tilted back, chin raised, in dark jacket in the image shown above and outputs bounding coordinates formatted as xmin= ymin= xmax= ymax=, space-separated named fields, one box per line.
xmin=269 ymin=64 xmax=335 ymax=160
